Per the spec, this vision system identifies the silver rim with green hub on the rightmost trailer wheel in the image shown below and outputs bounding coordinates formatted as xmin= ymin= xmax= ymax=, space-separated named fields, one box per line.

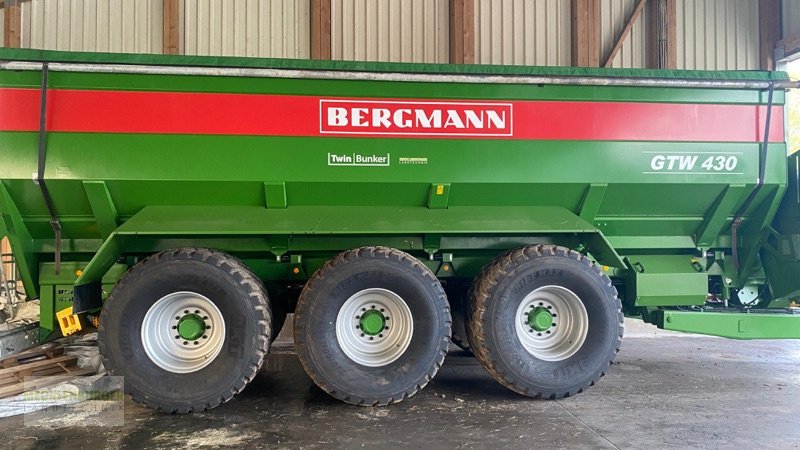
xmin=515 ymin=285 xmax=589 ymax=361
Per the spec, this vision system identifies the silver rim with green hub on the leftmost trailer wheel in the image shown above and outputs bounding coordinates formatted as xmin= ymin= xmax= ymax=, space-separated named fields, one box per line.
xmin=142 ymin=291 xmax=225 ymax=373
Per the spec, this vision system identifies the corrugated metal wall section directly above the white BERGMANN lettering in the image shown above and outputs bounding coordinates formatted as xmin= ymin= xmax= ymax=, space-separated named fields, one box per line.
xmin=331 ymin=0 xmax=450 ymax=63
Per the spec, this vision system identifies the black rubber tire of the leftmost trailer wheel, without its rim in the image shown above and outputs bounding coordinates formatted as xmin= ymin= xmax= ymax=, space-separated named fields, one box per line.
xmin=98 ymin=248 xmax=272 ymax=414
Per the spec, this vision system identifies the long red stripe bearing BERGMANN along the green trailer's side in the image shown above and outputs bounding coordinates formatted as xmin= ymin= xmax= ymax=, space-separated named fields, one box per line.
xmin=0 ymin=88 xmax=784 ymax=142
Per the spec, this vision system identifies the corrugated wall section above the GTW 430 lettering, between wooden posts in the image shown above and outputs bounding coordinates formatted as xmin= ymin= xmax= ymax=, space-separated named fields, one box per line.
xmin=676 ymin=0 xmax=759 ymax=70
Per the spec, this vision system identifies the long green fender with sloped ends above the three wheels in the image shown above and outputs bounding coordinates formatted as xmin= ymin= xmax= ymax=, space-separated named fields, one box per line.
xmin=75 ymin=206 xmax=624 ymax=285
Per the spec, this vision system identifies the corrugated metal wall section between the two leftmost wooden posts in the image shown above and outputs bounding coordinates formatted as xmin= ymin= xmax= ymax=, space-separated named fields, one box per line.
xmin=21 ymin=0 xmax=163 ymax=53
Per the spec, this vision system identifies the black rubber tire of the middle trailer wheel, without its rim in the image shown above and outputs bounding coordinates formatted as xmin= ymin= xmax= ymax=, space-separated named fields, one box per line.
xmin=294 ymin=247 xmax=451 ymax=406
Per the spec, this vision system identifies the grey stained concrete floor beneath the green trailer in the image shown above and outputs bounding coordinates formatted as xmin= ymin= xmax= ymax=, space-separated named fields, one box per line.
xmin=0 ymin=321 xmax=800 ymax=449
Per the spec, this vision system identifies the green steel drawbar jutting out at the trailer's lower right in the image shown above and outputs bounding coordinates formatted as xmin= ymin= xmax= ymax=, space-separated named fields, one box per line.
xmin=659 ymin=311 xmax=800 ymax=339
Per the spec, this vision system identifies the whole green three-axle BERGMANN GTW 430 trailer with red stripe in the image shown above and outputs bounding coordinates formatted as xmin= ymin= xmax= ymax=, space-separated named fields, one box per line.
xmin=0 ymin=49 xmax=800 ymax=412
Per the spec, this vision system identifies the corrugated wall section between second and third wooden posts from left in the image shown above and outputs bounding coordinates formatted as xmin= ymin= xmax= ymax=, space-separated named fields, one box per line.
xmin=179 ymin=0 xmax=311 ymax=58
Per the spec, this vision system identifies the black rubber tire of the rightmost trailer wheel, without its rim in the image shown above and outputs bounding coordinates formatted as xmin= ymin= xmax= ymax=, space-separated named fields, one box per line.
xmin=467 ymin=245 xmax=623 ymax=399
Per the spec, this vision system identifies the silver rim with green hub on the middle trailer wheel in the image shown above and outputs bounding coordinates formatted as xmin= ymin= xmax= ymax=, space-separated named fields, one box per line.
xmin=336 ymin=288 xmax=414 ymax=367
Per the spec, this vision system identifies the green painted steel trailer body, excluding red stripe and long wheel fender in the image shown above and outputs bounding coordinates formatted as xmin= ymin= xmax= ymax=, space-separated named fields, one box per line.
xmin=0 ymin=49 xmax=800 ymax=340
